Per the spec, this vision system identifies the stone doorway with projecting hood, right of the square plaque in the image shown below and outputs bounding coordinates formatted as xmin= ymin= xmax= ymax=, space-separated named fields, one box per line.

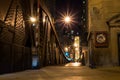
xmin=107 ymin=13 xmax=120 ymax=66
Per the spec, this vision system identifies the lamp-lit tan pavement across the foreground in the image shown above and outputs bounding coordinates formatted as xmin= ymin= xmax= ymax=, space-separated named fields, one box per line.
xmin=0 ymin=63 xmax=120 ymax=80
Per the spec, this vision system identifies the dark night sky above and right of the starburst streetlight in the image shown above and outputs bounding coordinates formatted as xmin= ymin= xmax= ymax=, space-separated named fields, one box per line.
xmin=56 ymin=0 xmax=83 ymax=33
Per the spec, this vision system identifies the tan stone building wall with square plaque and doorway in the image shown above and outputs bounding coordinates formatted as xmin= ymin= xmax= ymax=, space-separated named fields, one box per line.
xmin=87 ymin=0 xmax=120 ymax=66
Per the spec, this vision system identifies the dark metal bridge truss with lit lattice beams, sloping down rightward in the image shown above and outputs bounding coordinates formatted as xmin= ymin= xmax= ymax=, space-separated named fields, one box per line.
xmin=0 ymin=0 xmax=67 ymax=74
